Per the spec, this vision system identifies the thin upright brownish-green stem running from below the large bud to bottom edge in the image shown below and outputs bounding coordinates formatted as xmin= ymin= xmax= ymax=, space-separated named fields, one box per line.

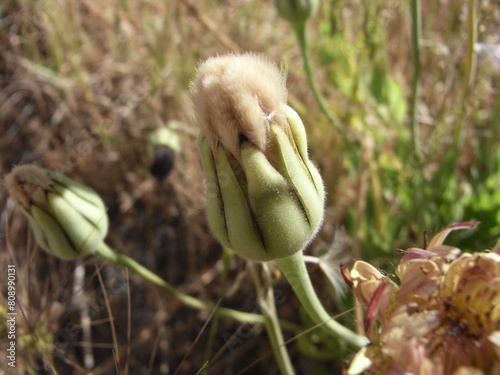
xmin=249 ymin=262 xmax=295 ymax=375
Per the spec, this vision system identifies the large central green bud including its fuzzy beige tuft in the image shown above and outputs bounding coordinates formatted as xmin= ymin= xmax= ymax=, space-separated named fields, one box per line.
xmin=192 ymin=54 xmax=324 ymax=261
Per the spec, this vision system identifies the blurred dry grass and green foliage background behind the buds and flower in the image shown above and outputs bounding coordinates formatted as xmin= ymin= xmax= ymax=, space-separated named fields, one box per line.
xmin=0 ymin=0 xmax=500 ymax=375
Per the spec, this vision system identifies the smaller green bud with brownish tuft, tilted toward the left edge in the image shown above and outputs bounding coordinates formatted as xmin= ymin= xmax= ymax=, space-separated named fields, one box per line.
xmin=5 ymin=165 xmax=108 ymax=259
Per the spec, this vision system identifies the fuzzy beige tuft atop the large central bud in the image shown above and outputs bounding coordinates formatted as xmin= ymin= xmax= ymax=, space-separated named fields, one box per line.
xmin=191 ymin=53 xmax=287 ymax=160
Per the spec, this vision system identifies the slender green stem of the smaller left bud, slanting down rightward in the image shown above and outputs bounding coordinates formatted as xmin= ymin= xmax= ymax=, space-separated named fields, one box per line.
xmin=96 ymin=242 xmax=297 ymax=330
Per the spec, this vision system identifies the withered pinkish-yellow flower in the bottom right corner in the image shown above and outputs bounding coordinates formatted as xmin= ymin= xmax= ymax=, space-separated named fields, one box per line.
xmin=348 ymin=223 xmax=500 ymax=375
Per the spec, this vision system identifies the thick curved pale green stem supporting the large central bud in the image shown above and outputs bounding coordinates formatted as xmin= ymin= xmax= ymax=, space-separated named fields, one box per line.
xmin=274 ymin=251 xmax=369 ymax=348
